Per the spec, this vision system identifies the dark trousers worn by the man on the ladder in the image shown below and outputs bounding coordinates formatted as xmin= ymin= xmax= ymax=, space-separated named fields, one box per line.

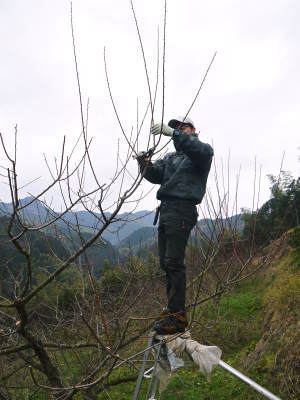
xmin=158 ymin=199 xmax=198 ymax=313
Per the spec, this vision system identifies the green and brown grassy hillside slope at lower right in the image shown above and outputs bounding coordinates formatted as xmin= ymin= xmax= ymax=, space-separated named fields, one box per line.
xmin=98 ymin=227 xmax=300 ymax=400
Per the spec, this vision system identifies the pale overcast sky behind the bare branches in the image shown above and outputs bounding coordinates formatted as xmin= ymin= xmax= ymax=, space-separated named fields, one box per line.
xmin=0 ymin=0 xmax=300 ymax=217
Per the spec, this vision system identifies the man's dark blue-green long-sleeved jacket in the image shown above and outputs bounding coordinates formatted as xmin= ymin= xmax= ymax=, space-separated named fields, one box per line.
xmin=139 ymin=130 xmax=214 ymax=204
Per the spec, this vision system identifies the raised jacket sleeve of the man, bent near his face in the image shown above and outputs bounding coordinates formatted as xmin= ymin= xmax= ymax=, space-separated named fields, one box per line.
xmin=173 ymin=131 xmax=214 ymax=168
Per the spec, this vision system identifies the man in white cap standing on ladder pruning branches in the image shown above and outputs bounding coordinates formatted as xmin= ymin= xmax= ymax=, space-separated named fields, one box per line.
xmin=137 ymin=117 xmax=214 ymax=335
